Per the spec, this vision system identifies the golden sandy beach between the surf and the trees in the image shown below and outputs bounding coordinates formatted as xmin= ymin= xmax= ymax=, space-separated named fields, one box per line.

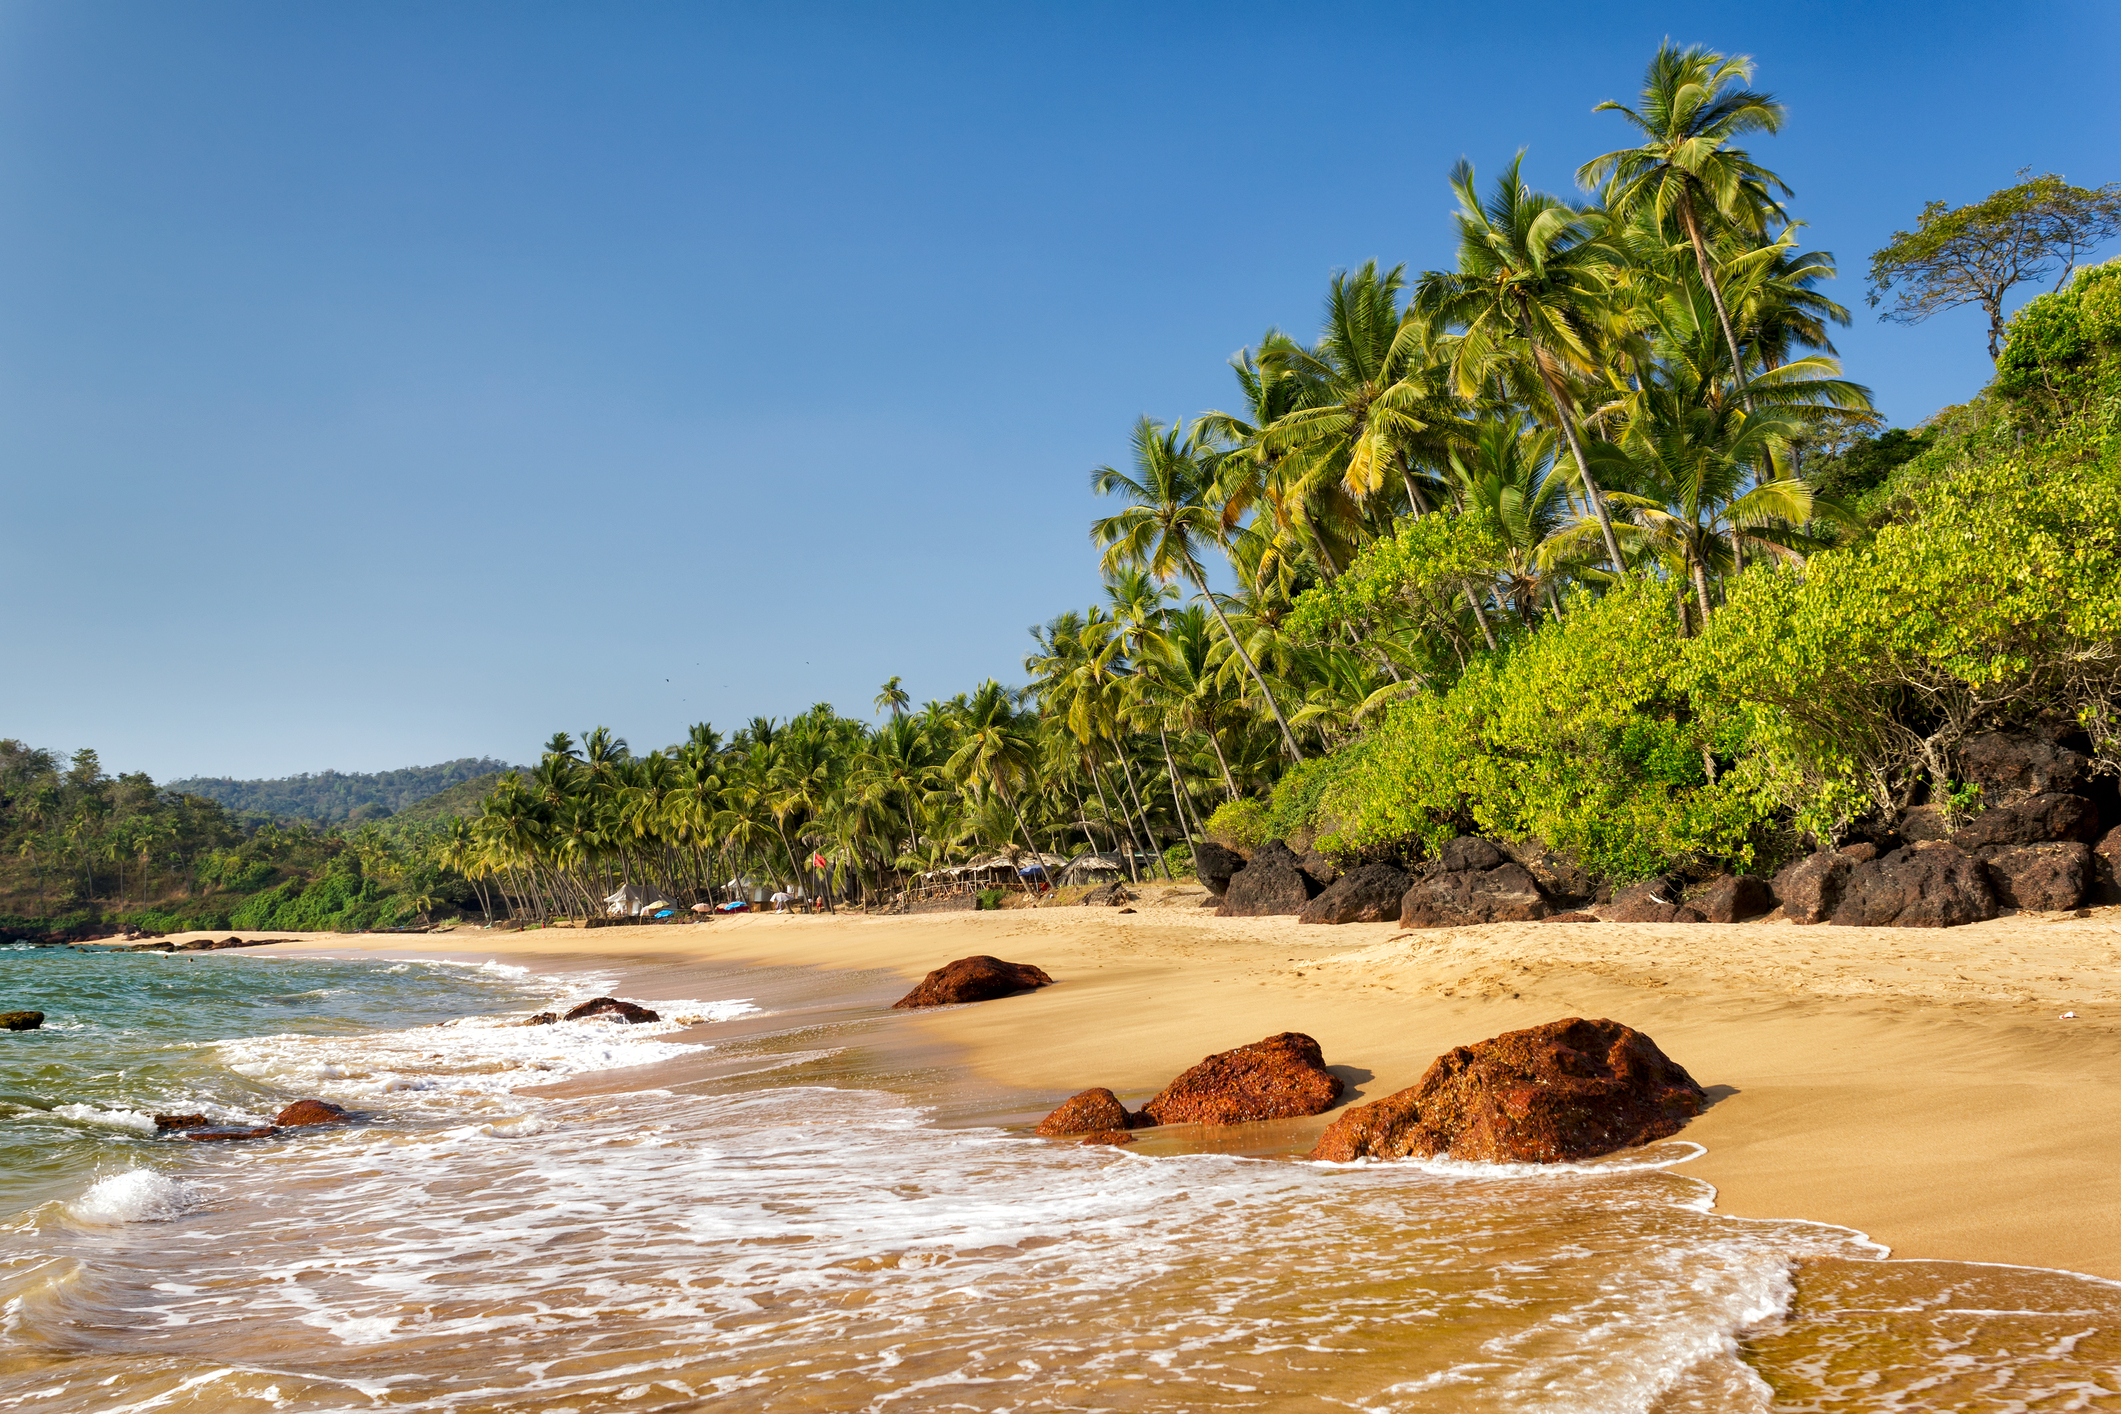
xmin=211 ymin=888 xmax=2121 ymax=1280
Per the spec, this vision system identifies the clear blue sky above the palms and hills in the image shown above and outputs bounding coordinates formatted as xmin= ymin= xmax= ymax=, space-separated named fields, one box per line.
xmin=0 ymin=0 xmax=2121 ymax=778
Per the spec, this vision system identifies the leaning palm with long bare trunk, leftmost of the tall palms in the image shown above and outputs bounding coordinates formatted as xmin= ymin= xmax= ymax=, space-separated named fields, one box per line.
xmin=1090 ymin=418 xmax=1304 ymax=761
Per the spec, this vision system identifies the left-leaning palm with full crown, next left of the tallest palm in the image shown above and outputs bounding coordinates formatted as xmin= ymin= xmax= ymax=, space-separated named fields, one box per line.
xmin=1419 ymin=153 xmax=1627 ymax=575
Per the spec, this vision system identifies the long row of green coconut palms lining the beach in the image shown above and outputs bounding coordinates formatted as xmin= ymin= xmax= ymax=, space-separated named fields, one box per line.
xmin=445 ymin=45 xmax=1871 ymax=914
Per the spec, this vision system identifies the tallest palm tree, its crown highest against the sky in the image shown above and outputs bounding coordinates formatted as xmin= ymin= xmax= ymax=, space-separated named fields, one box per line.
xmin=1576 ymin=40 xmax=1790 ymax=411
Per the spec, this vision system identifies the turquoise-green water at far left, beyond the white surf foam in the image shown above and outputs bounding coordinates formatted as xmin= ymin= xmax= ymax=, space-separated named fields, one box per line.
xmin=0 ymin=945 xmax=554 ymax=1215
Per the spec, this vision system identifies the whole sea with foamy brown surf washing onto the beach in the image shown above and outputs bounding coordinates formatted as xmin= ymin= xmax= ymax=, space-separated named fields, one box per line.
xmin=0 ymin=950 xmax=2121 ymax=1414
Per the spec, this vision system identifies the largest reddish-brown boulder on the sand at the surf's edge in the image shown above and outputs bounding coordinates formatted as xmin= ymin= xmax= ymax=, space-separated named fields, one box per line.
xmin=1311 ymin=1018 xmax=1707 ymax=1164
